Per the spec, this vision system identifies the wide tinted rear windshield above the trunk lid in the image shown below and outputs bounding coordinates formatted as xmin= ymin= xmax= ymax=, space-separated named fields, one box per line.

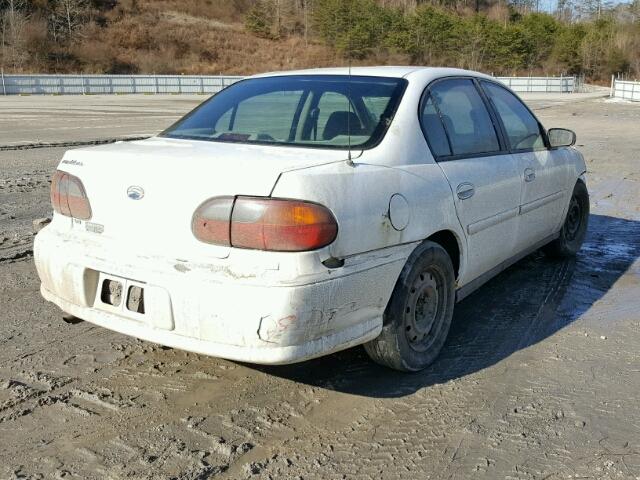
xmin=161 ymin=75 xmax=407 ymax=149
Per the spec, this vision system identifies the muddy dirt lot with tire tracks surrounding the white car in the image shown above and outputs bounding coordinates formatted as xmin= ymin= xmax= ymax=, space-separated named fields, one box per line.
xmin=0 ymin=93 xmax=640 ymax=480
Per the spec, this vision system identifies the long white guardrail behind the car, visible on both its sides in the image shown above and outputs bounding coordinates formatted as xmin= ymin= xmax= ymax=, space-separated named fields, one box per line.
xmin=0 ymin=74 xmax=579 ymax=95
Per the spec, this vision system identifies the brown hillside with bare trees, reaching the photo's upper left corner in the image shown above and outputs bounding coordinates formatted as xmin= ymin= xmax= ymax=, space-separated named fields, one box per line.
xmin=0 ymin=0 xmax=337 ymax=74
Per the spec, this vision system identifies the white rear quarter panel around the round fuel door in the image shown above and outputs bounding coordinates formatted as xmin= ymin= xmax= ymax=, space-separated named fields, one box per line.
xmin=273 ymin=162 xmax=464 ymax=265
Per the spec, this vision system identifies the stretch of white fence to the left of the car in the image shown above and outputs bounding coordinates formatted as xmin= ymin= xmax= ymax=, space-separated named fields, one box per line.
xmin=0 ymin=75 xmax=242 ymax=95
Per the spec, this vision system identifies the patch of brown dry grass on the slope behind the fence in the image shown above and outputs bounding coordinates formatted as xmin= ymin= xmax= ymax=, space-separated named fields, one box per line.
xmin=62 ymin=0 xmax=343 ymax=75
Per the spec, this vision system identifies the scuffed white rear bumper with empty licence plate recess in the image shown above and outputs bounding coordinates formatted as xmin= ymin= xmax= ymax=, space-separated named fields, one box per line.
xmin=34 ymin=226 xmax=413 ymax=364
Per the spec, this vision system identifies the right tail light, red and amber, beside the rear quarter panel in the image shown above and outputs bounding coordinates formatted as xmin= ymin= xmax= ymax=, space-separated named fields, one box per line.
xmin=192 ymin=197 xmax=338 ymax=252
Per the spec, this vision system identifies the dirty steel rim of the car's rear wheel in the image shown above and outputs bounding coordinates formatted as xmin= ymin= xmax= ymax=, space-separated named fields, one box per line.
xmin=404 ymin=266 xmax=446 ymax=352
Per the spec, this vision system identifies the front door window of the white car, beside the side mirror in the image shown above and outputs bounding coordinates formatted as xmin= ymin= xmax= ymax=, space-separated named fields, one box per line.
xmin=482 ymin=82 xmax=545 ymax=150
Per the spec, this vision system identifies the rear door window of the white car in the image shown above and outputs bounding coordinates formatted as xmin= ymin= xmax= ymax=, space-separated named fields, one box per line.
xmin=430 ymin=79 xmax=500 ymax=155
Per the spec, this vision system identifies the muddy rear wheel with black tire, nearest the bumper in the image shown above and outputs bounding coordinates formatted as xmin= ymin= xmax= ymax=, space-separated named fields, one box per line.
xmin=364 ymin=241 xmax=455 ymax=372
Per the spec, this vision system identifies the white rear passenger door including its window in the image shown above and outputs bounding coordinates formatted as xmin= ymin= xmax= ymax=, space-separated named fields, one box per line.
xmin=420 ymin=78 xmax=522 ymax=283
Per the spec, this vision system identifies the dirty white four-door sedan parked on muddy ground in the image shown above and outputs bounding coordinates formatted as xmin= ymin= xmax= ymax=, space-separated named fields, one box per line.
xmin=35 ymin=67 xmax=589 ymax=371
